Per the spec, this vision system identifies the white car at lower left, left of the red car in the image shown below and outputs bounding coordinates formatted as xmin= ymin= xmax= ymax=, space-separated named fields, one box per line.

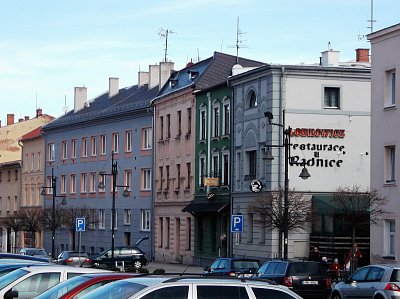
xmin=0 ymin=264 xmax=108 ymax=299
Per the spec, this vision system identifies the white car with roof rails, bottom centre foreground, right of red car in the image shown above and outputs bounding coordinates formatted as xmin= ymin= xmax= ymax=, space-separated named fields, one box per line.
xmin=81 ymin=276 xmax=301 ymax=299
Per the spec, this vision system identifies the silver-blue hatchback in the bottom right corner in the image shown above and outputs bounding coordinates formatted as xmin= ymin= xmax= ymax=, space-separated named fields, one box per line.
xmin=331 ymin=265 xmax=400 ymax=299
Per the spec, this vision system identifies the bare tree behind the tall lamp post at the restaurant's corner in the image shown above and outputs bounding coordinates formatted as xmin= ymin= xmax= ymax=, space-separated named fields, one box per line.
xmin=249 ymin=189 xmax=312 ymax=256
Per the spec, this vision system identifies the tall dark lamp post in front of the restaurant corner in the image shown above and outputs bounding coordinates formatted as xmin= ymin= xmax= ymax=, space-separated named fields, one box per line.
xmin=264 ymin=110 xmax=311 ymax=259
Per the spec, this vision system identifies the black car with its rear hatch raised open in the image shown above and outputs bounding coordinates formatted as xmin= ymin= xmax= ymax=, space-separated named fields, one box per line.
xmin=92 ymin=236 xmax=149 ymax=269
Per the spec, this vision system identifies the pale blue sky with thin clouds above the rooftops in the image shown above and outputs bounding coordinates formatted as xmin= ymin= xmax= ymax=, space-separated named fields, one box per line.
xmin=0 ymin=0 xmax=400 ymax=126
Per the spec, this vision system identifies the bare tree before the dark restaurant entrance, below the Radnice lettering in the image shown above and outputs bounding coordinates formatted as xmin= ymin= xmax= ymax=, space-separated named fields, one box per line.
xmin=332 ymin=186 xmax=389 ymax=243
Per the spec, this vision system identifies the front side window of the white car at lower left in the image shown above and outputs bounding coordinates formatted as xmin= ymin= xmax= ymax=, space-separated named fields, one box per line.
xmin=12 ymin=273 xmax=60 ymax=299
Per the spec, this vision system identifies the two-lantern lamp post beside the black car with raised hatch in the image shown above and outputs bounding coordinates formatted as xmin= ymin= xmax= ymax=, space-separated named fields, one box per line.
xmin=98 ymin=151 xmax=130 ymax=267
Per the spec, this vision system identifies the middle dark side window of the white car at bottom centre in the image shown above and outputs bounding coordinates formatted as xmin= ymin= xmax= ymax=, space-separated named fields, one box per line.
xmin=197 ymin=286 xmax=249 ymax=299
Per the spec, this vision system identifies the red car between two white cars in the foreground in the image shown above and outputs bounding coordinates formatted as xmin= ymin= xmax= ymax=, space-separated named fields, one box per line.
xmin=35 ymin=272 xmax=138 ymax=299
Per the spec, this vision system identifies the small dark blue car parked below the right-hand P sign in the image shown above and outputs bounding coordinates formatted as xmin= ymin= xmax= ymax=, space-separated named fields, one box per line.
xmin=204 ymin=258 xmax=260 ymax=277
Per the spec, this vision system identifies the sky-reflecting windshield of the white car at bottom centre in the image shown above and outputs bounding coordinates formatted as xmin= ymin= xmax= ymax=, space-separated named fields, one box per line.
xmin=82 ymin=280 xmax=146 ymax=299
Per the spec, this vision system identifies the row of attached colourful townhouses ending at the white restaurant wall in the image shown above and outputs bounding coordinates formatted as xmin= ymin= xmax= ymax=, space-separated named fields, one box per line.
xmin=0 ymin=23 xmax=398 ymax=265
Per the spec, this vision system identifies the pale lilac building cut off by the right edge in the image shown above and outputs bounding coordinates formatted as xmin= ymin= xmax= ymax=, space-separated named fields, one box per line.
xmin=368 ymin=24 xmax=400 ymax=263
